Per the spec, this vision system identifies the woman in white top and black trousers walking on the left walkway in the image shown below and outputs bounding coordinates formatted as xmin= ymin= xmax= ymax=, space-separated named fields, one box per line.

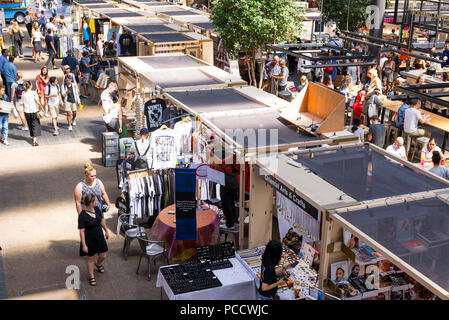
xmin=22 ymin=81 xmax=43 ymax=147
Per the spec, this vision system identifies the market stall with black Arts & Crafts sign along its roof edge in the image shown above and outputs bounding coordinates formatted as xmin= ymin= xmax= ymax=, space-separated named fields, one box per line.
xmin=249 ymin=144 xmax=449 ymax=299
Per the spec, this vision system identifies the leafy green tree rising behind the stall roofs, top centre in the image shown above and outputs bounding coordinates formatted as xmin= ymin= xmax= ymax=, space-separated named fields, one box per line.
xmin=211 ymin=0 xmax=304 ymax=85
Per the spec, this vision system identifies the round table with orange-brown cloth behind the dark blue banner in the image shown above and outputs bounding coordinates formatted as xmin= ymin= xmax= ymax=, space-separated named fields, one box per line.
xmin=150 ymin=205 xmax=219 ymax=261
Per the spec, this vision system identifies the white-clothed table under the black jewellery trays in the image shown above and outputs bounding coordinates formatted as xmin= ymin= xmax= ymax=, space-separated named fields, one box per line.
xmin=156 ymin=258 xmax=257 ymax=300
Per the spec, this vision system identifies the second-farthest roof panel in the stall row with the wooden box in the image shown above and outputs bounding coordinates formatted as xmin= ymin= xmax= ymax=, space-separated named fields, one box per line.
xmin=141 ymin=68 xmax=220 ymax=89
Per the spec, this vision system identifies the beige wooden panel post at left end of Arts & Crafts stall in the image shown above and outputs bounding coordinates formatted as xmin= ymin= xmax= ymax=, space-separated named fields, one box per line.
xmin=248 ymin=164 xmax=273 ymax=248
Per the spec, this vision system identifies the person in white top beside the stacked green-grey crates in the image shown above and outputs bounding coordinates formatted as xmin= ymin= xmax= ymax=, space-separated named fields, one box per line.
xmin=101 ymin=81 xmax=122 ymax=134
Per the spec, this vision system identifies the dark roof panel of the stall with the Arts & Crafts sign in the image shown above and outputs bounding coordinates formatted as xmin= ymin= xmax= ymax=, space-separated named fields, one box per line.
xmin=288 ymin=145 xmax=449 ymax=201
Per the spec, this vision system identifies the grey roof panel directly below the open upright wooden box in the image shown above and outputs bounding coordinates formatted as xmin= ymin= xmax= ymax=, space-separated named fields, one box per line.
xmin=205 ymin=108 xmax=320 ymax=148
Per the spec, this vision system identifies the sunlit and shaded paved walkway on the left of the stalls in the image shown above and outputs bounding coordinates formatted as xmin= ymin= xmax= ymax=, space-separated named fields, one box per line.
xmin=0 ymin=30 xmax=164 ymax=299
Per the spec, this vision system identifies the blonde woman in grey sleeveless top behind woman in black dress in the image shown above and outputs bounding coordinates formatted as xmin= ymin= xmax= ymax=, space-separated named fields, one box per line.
xmin=74 ymin=163 xmax=111 ymax=214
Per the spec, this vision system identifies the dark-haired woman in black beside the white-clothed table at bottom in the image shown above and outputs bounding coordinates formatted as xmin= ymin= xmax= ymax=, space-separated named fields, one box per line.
xmin=257 ymin=240 xmax=291 ymax=300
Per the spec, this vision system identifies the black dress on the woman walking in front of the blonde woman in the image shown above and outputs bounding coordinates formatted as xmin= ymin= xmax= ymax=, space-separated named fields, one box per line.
xmin=78 ymin=207 xmax=108 ymax=257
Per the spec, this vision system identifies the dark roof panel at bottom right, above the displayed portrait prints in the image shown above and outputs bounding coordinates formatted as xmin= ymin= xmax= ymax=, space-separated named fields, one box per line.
xmin=336 ymin=198 xmax=449 ymax=295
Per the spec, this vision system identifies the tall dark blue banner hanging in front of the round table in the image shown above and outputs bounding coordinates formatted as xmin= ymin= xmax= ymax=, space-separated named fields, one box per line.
xmin=175 ymin=168 xmax=196 ymax=240
